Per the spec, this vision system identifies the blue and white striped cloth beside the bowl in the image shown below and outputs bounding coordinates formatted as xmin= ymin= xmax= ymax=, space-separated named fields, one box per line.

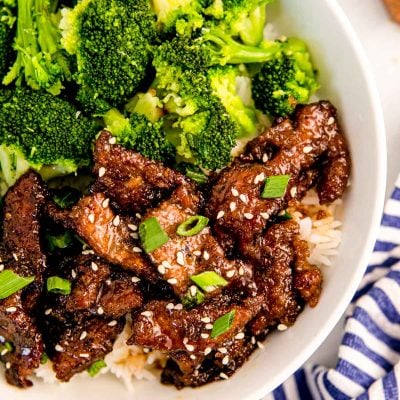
xmin=264 ymin=177 xmax=400 ymax=400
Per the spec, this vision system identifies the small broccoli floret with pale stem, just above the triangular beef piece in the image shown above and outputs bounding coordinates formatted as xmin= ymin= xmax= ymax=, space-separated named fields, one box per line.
xmin=104 ymin=109 xmax=175 ymax=163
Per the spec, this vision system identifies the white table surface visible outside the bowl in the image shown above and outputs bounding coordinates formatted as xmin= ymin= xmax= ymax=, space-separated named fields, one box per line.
xmin=309 ymin=0 xmax=400 ymax=366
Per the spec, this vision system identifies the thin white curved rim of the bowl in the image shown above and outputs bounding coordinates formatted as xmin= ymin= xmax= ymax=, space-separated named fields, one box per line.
xmin=244 ymin=0 xmax=387 ymax=400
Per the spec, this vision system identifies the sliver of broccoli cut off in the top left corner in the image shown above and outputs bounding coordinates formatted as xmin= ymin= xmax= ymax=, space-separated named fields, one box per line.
xmin=0 ymin=0 xmax=16 ymax=81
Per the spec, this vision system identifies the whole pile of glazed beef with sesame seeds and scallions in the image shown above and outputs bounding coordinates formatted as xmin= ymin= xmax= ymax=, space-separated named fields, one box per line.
xmin=0 ymin=101 xmax=350 ymax=388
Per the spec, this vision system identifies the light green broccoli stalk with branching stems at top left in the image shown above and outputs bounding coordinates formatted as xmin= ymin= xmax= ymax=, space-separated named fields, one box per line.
xmin=3 ymin=0 xmax=70 ymax=95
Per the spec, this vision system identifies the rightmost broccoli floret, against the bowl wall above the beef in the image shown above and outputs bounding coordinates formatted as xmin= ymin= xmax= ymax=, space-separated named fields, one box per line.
xmin=252 ymin=38 xmax=319 ymax=116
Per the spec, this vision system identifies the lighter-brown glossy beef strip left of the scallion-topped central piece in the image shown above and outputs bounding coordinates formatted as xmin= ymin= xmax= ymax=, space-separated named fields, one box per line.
xmin=46 ymin=193 xmax=158 ymax=282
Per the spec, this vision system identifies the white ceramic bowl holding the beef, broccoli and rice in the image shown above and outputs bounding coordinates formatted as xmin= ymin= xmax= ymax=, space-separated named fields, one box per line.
xmin=0 ymin=0 xmax=386 ymax=400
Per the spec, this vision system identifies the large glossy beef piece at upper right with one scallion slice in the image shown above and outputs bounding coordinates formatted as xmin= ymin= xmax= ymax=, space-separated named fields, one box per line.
xmin=207 ymin=101 xmax=350 ymax=253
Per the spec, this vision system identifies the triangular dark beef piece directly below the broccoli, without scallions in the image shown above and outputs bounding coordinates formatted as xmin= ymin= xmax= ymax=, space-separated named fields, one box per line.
xmin=93 ymin=131 xmax=186 ymax=212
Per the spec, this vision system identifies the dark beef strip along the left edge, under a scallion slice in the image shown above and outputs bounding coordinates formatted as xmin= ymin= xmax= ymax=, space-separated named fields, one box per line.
xmin=0 ymin=172 xmax=47 ymax=387
